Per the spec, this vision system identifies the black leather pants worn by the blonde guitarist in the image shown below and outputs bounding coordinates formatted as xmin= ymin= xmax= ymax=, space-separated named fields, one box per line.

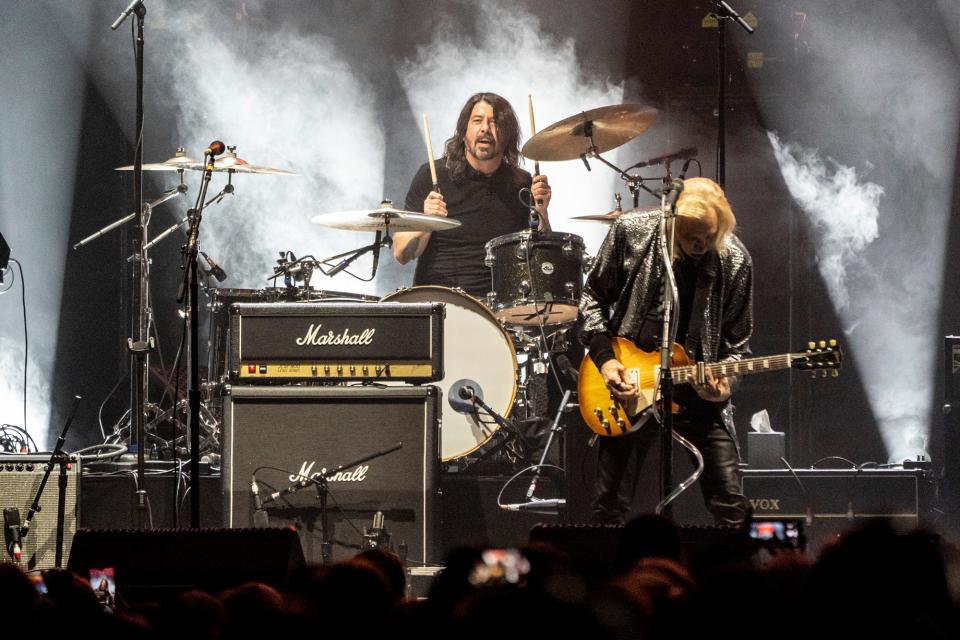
xmin=592 ymin=419 xmax=748 ymax=524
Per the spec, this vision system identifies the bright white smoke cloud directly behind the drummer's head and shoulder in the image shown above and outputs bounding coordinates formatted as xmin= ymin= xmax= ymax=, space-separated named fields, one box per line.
xmin=399 ymin=1 xmax=623 ymax=253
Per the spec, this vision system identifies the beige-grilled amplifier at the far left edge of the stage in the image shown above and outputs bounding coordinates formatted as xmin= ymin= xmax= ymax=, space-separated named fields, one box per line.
xmin=0 ymin=454 xmax=80 ymax=571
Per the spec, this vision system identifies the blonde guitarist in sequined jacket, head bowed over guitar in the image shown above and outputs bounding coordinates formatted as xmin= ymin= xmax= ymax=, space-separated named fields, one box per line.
xmin=580 ymin=178 xmax=753 ymax=524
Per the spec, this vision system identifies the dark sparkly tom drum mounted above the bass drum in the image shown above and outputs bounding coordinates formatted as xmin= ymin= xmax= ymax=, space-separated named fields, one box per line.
xmin=486 ymin=231 xmax=586 ymax=325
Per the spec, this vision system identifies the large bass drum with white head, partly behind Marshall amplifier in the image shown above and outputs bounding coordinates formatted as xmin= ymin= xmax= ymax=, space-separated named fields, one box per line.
xmin=383 ymin=286 xmax=517 ymax=462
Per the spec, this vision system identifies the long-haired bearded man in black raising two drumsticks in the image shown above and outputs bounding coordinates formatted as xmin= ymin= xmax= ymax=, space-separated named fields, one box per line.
xmin=393 ymin=93 xmax=551 ymax=300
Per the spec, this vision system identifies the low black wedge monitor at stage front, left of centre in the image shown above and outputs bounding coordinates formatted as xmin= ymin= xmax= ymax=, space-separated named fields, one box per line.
xmin=67 ymin=529 xmax=304 ymax=602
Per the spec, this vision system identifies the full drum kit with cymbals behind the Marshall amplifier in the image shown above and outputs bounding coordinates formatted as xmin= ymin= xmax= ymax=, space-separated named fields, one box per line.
xmin=84 ymin=104 xmax=695 ymax=480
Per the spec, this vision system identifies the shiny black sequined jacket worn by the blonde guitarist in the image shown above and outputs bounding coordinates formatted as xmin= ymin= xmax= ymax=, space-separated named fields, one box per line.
xmin=580 ymin=211 xmax=753 ymax=433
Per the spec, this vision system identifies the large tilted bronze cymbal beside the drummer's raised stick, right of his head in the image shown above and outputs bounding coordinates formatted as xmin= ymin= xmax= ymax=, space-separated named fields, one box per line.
xmin=521 ymin=104 xmax=657 ymax=161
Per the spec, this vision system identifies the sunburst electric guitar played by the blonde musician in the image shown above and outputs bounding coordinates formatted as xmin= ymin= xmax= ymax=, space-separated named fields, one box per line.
xmin=577 ymin=338 xmax=843 ymax=436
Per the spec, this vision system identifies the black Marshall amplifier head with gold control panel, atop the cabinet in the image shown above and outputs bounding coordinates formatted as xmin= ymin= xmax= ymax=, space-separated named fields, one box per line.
xmin=229 ymin=302 xmax=445 ymax=384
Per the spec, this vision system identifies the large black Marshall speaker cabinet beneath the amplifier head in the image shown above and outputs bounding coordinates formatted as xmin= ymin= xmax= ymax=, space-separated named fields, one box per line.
xmin=223 ymin=386 xmax=440 ymax=564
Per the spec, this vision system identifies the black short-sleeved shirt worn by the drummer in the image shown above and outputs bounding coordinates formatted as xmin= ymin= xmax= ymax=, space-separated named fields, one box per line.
xmin=404 ymin=158 xmax=531 ymax=299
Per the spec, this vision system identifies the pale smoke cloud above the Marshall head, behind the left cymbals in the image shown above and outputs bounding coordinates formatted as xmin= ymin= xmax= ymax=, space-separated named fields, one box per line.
xmin=155 ymin=4 xmax=384 ymax=291
